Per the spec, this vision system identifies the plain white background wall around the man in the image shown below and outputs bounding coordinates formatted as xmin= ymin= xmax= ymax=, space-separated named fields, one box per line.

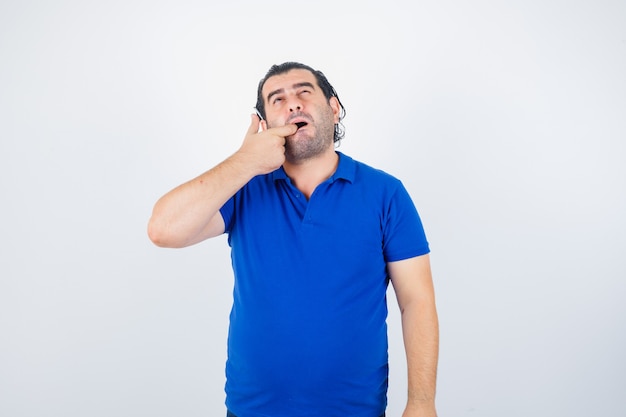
xmin=0 ymin=0 xmax=626 ymax=417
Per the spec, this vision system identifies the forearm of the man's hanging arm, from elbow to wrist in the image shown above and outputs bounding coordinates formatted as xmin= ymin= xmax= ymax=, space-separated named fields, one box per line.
xmin=402 ymin=299 xmax=439 ymax=415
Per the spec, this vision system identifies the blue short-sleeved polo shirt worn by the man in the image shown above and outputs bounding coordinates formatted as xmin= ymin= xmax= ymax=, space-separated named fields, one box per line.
xmin=220 ymin=153 xmax=429 ymax=417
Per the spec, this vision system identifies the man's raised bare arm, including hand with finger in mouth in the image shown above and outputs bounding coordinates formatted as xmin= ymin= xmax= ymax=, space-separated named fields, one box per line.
xmin=148 ymin=115 xmax=297 ymax=248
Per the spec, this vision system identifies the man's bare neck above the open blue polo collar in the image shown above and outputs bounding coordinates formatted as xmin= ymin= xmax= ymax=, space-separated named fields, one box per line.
xmin=283 ymin=147 xmax=339 ymax=199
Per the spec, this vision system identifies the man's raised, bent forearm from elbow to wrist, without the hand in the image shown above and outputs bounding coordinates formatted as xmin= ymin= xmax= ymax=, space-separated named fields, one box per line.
xmin=148 ymin=153 xmax=255 ymax=247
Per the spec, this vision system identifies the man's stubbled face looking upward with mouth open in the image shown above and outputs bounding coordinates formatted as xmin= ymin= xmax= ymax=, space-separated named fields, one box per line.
xmin=262 ymin=69 xmax=339 ymax=163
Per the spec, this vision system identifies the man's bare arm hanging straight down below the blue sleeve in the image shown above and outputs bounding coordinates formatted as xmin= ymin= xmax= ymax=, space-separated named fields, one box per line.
xmin=387 ymin=255 xmax=439 ymax=417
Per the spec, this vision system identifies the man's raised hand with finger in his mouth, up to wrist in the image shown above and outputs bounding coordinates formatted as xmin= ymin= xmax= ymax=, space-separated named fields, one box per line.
xmin=236 ymin=114 xmax=298 ymax=175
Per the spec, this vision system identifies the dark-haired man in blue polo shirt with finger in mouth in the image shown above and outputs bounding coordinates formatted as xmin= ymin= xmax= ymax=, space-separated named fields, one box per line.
xmin=148 ymin=62 xmax=438 ymax=417
